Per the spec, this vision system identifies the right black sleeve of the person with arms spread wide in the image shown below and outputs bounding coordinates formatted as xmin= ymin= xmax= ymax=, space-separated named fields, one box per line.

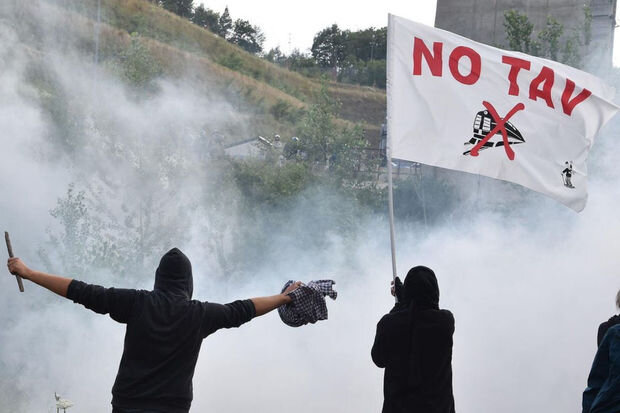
xmin=202 ymin=300 xmax=256 ymax=337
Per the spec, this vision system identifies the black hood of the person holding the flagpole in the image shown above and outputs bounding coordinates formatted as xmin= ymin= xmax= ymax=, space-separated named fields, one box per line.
xmin=403 ymin=265 xmax=439 ymax=310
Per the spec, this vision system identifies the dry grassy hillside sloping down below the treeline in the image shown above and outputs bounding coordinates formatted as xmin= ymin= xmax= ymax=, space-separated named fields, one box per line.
xmin=17 ymin=0 xmax=385 ymax=142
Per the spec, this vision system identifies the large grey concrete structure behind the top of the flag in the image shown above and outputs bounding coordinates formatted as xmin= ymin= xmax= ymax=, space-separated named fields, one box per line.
xmin=435 ymin=0 xmax=617 ymax=72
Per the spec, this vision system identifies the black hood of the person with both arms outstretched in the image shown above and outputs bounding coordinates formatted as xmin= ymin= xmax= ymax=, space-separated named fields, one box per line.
xmin=154 ymin=248 xmax=194 ymax=300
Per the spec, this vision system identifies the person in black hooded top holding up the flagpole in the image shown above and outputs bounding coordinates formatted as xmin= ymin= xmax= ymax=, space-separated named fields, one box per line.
xmin=371 ymin=266 xmax=454 ymax=413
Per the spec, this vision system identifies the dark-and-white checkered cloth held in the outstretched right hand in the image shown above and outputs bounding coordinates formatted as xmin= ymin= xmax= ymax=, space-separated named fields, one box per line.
xmin=278 ymin=280 xmax=338 ymax=327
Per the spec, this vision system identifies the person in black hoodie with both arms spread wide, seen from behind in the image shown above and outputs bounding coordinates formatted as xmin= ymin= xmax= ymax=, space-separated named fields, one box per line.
xmin=8 ymin=248 xmax=299 ymax=413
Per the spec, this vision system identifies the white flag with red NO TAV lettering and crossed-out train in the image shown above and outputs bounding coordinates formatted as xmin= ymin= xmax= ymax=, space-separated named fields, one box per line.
xmin=387 ymin=15 xmax=618 ymax=211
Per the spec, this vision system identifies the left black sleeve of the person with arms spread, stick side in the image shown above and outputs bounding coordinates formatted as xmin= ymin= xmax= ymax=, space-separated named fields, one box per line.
xmin=67 ymin=280 xmax=139 ymax=323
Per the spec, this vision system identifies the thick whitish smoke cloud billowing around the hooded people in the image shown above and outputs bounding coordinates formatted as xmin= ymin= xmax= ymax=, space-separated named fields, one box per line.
xmin=0 ymin=2 xmax=620 ymax=413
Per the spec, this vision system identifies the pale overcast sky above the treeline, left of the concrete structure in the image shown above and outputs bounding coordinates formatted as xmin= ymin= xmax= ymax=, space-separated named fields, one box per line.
xmin=194 ymin=0 xmax=436 ymax=54
